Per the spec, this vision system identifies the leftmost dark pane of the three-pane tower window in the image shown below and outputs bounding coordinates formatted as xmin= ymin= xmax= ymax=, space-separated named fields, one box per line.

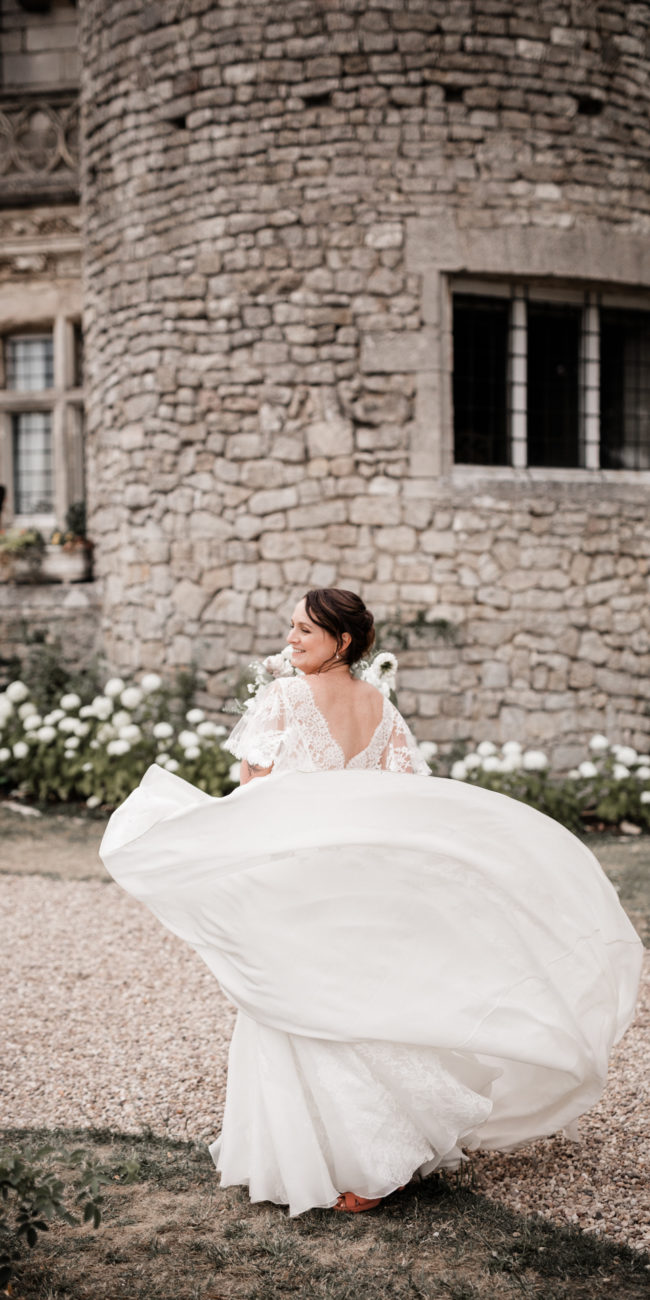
xmin=454 ymin=294 xmax=510 ymax=465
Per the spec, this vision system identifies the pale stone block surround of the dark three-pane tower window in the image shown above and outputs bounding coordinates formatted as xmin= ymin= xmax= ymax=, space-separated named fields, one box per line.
xmin=360 ymin=220 xmax=650 ymax=491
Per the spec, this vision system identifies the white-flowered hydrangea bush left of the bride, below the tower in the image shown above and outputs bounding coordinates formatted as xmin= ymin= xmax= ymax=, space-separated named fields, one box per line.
xmin=0 ymin=672 xmax=237 ymax=809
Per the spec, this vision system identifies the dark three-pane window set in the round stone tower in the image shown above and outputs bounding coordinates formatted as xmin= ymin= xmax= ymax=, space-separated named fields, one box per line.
xmin=452 ymin=285 xmax=650 ymax=469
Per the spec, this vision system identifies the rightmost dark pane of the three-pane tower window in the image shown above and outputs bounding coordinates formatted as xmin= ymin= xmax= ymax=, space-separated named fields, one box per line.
xmin=601 ymin=308 xmax=650 ymax=469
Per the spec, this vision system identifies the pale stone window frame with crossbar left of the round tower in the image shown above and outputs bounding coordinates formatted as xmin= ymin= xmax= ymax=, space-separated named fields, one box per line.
xmin=0 ymin=282 xmax=85 ymax=530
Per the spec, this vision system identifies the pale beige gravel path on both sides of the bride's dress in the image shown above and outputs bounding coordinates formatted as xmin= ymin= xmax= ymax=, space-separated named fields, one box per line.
xmin=0 ymin=814 xmax=650 ymax=1251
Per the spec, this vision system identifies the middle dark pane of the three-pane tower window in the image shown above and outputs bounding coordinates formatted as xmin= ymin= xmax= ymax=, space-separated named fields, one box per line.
xmin=528 ymin=303 xmax=582 ymax=468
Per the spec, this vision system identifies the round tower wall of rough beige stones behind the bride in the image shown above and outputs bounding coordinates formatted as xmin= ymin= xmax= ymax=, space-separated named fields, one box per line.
xmin=82 ymin=0 xmax=650 ymax=761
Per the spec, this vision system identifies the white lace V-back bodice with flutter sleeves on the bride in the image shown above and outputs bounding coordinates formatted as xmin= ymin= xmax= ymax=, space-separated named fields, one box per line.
xmin=224 ymin=677 xmax=429 ymax=776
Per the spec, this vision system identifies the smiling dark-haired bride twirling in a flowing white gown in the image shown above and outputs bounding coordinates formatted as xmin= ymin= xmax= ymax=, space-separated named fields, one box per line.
xmin=100 ymin=588 xmax=642 ymax=1214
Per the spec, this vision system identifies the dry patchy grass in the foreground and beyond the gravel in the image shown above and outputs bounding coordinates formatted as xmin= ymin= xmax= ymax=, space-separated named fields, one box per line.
xmin=0 ymin=806 xmax=650 ymax=1300
